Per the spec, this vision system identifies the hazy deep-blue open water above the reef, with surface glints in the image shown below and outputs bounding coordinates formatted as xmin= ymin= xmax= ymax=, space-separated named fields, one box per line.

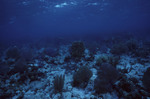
xmin=0 ymin=0 xmax=150 ymax=40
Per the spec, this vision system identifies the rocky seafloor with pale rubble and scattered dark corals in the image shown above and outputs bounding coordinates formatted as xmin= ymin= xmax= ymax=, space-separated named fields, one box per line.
xmin=0 ymin=37 xmax=150 ymax=99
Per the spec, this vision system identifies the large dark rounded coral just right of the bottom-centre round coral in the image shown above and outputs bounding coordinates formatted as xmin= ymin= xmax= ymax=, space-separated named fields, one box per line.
xmin=94 ymin=63 xmax=119 ymax=93
